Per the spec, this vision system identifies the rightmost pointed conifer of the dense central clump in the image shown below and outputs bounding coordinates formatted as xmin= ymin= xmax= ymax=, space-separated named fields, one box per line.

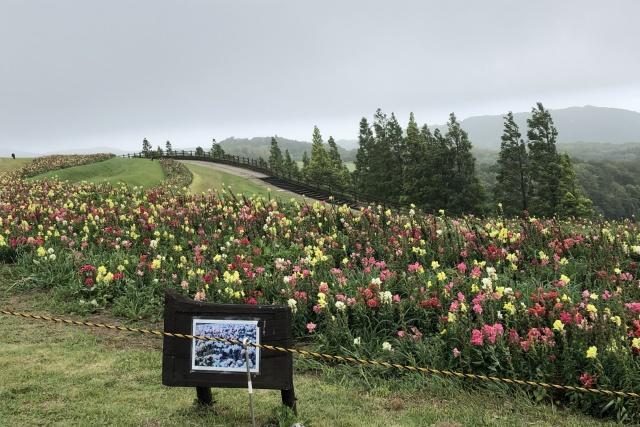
xmin=445 ymin=113 xmax=484 ymax=213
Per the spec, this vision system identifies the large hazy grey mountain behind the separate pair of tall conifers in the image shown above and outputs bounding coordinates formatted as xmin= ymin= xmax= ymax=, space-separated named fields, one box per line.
xmin=434 ymin=105 xmax=640 ymax=149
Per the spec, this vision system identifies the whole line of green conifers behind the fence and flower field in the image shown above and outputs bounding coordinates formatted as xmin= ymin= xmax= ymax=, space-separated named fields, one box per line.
xmin=143 ymin=103 xmax=593 ymax=217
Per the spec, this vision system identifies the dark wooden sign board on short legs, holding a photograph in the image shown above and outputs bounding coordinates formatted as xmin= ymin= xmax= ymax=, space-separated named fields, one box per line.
xmin=162 ymin=290 xmax=295 ymax=409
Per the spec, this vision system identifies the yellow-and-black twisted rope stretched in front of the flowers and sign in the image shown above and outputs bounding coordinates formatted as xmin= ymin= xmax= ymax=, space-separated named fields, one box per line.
xmin=0 ymin=310 xmax=640 ymax=399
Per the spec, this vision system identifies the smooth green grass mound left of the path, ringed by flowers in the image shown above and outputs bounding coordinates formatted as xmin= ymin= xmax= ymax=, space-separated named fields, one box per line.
xmin=33 ymin=157 xmax=164 ymax=188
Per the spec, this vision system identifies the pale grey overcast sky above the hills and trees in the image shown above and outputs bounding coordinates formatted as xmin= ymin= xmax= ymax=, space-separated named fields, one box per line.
xmin=0 ymin=0 xmax=640 ymax=155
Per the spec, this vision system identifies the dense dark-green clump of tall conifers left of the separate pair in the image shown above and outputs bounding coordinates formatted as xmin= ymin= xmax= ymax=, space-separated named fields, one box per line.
xmin=354 ymin=110 xmax=483 ymax=213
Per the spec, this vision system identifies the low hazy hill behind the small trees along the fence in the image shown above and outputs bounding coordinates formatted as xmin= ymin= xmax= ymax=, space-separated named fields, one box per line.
xmin=218 ymin=136 xmax=355 ymax=162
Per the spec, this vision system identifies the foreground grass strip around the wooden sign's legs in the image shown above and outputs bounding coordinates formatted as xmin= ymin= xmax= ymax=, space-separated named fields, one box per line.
xmin=0 ymin=266 xmax=612 ymax=427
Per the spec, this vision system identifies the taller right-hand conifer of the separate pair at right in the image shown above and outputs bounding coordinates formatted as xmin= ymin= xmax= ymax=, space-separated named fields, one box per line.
xmin=527 ymin=102 xmax=562 ymax=217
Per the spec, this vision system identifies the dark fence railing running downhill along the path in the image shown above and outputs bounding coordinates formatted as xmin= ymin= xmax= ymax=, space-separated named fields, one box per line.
xmin=122 ymin=150 xmax=406 ymax=209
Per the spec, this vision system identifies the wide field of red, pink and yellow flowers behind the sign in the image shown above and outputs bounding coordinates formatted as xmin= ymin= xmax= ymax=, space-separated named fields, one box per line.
xmin=0 ymin=156 xmax=640 ymax=421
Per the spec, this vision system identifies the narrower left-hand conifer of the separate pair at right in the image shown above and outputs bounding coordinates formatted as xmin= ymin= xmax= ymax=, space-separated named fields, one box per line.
xmin=493 ymin=111 xmax=529 ymax=215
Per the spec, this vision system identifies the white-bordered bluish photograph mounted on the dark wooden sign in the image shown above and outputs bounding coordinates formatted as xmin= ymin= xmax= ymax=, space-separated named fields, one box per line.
xmin=191 ymin=319 xmax=260 ymax=373
